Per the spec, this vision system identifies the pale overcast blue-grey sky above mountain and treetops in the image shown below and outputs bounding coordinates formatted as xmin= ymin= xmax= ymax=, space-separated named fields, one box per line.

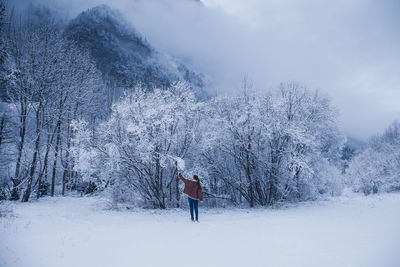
xmin=11 ymin=0 xmax=400 ymax=140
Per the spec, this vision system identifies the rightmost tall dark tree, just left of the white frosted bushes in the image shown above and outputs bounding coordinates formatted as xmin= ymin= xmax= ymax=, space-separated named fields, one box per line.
xmin=56 ymin=44 xmax=105 ymax=195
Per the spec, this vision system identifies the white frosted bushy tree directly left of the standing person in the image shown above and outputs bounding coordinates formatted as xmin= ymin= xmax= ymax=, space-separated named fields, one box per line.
xmin=73 ymin=83 xmax=199 ymax=208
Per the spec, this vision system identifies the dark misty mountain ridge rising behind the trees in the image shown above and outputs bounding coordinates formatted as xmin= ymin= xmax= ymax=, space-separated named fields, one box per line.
xmin=64 ymin=5 xmax=207 ymax=98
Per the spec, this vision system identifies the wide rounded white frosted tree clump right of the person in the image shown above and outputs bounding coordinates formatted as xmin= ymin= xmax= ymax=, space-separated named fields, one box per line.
xmin=203 ymin=80 xmax=344 ymax=207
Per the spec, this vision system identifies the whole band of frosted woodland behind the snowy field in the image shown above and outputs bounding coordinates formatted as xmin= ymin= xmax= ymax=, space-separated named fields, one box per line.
xmin=0 ymin=1 xmax=400 ymax=209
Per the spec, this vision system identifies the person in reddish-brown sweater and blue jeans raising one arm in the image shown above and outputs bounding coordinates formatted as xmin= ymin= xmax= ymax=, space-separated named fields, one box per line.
xmin=178 ymin=171 xmax=203 ymax=222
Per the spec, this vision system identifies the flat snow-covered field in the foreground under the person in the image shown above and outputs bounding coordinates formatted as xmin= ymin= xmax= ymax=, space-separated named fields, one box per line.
xmin=0 ymin=194 xmax=400 ymax=267
